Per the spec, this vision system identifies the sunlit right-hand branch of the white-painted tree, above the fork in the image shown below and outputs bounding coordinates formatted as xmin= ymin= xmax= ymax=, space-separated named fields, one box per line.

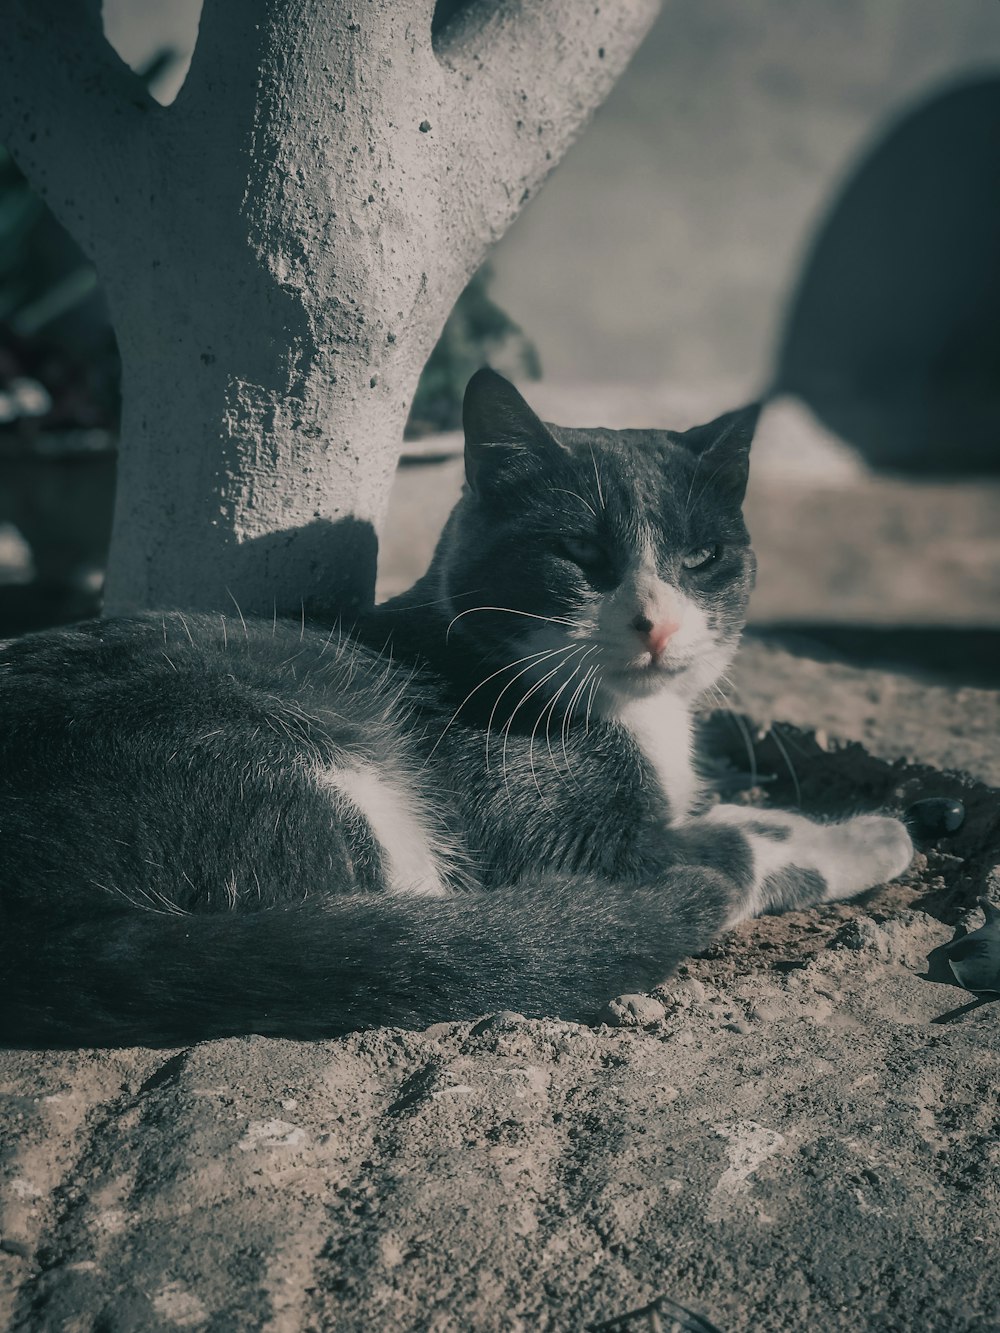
xmin=437 ymin=0 xmax=661 ymax=243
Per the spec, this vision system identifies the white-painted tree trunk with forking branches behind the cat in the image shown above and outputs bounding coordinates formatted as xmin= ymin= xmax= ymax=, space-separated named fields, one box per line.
xmin=0 ymin=0 xmax=659 ymax=615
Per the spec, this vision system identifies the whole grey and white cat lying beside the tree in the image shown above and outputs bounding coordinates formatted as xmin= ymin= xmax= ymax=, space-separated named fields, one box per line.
xmin=0 ymin=369 xmax=912 ymax=1046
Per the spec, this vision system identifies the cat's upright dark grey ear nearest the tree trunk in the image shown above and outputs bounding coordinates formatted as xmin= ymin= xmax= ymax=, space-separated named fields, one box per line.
xmin=461 ymin=367 xmax=563 ymax=493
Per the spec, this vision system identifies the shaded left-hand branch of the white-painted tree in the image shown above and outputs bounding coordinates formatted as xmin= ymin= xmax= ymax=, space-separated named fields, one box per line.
xmin=0 ymin=0 xmax=160 ymax=259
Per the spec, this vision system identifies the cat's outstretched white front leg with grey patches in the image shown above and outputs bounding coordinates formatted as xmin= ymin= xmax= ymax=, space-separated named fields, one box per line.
xmin=697 ymin=805 xmax=913 ymax=925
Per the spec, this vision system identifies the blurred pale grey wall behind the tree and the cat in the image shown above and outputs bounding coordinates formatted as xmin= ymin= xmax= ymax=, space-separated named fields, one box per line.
xmin=104 ymin=0 xmax=1000 ymax=391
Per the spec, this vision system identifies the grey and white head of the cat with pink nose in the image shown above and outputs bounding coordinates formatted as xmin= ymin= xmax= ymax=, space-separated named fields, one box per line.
xmin=436 ymin=371 xmax=757 ymax=704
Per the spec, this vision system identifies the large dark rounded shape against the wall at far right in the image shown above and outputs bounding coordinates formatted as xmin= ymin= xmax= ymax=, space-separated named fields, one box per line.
xmin=776 ymin=73 xmax=1000 ymax=473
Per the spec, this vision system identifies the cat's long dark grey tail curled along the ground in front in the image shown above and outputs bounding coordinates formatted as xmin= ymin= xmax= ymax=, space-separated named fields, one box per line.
xmin=0 ymin=869 xmax=728 ymax=1046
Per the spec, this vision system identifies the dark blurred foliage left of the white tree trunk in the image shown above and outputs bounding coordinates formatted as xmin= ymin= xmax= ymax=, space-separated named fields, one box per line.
xmin=0 ymin=148 xmax=120 ymax=637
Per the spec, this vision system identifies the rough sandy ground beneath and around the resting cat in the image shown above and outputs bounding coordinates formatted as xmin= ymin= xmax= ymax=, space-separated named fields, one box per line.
xmin=0 ymin=402 xmax=1000 ymax=1333
